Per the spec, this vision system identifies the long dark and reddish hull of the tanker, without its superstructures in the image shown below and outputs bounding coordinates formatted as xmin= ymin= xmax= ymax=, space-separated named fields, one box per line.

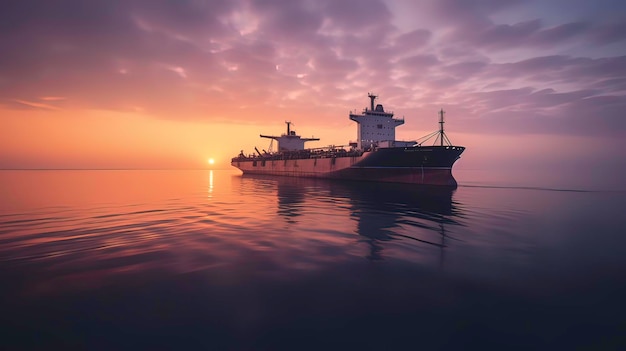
xmin=231 ymin=146 xmax=465 ymax=187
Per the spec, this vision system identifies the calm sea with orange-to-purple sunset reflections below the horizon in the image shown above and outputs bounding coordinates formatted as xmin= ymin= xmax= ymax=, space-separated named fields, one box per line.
xmin=0 ymin=170 xmax=626 ymax=350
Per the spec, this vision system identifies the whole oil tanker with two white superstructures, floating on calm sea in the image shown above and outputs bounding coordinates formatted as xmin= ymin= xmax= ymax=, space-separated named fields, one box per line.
xmin=231 ymin=94 xmax=465 ymax=187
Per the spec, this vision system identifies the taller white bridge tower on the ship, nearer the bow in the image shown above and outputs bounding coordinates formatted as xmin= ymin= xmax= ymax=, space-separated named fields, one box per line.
xmin=350 ymin=94 xmax=404 ymax=150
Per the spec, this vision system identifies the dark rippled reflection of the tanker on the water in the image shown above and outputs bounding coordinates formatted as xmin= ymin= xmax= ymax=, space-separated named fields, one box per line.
xmin=241 ymin=175 xmax=462 ymax=264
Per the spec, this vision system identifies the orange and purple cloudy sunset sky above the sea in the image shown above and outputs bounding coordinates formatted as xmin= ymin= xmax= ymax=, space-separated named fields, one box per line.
xmin=0 ymin=0 xmax=626 ymax=182
